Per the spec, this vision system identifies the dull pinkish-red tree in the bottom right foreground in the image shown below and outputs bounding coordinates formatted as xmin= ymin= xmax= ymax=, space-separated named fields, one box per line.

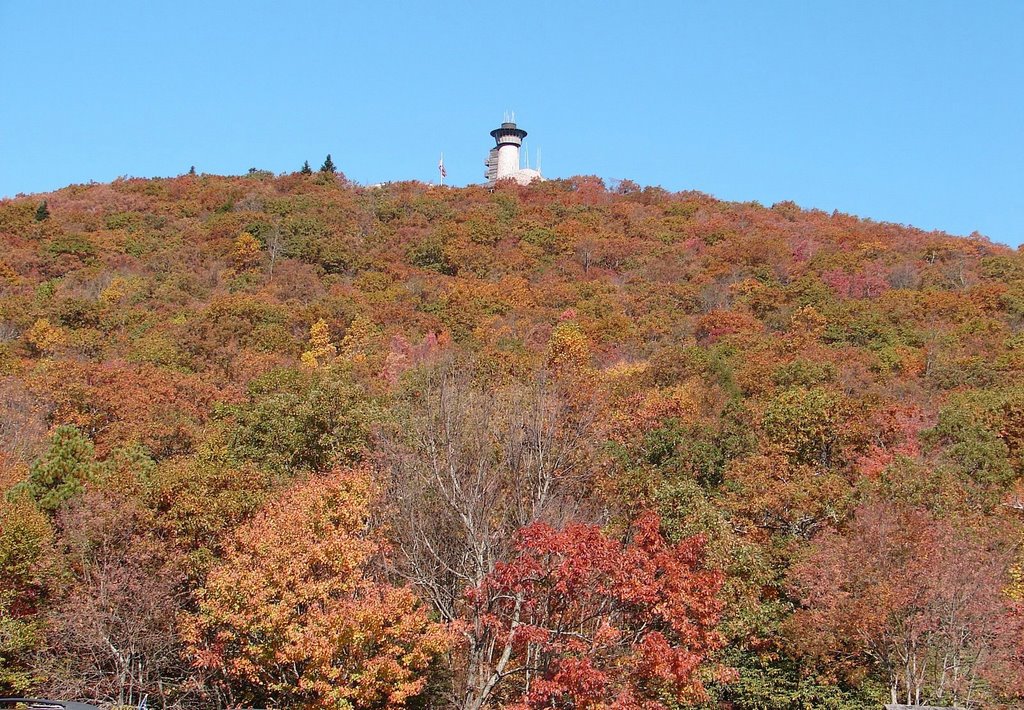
xmin=791 ymin=503 xmax=1021 ymax=708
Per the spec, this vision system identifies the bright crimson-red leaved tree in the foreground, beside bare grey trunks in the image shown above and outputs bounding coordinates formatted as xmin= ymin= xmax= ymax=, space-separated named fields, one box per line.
xmin=466 ymin=512 xmax=730 ymax=710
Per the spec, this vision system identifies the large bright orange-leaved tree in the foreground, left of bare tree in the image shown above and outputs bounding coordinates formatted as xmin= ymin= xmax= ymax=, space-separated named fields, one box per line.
xmin=184 ymin=469 xmax=451 ymax=708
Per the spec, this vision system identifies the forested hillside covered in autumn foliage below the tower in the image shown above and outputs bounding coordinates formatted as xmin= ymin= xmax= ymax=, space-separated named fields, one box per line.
xmin=0 ymin=171 xmax=1024 ymax=710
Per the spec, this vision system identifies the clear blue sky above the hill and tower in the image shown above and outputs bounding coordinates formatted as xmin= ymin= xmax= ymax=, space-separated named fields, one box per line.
xmin=0 ymin=0 xmax=1024 ymax=245
